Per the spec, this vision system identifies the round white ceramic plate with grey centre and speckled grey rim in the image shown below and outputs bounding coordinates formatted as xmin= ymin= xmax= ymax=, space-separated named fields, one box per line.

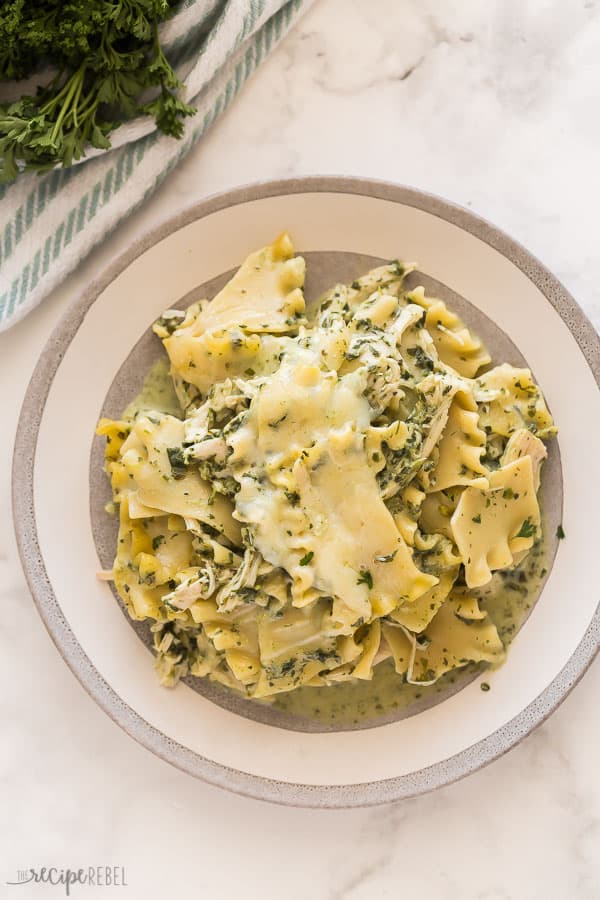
xmin=13 ymin=178 xmax=600 ymax=806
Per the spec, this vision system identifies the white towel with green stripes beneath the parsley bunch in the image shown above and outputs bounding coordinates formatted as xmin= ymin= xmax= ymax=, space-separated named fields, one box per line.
xmin=0 ymin=0 xmax=310 ymax=331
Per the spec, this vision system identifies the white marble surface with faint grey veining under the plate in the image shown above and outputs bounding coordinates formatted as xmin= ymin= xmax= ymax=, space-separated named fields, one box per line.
xmin=0 ymin=0 xmax=600 ymax=900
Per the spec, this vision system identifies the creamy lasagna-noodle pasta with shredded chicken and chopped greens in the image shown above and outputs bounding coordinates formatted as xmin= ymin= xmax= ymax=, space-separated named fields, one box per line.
xmin=98 ymin=234 xmax=556 ymax=698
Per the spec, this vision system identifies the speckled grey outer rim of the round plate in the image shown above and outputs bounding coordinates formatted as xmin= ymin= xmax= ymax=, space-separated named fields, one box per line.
xmin=12 ymin=175 xmax=600 ymax=808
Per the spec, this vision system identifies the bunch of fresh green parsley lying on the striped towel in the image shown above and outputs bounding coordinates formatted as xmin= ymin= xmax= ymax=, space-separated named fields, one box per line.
xmin=0 ymin=0 xmax=196 ymax=182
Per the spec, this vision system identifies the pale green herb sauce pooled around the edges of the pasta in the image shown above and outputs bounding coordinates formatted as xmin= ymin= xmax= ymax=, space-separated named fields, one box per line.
xmin=123 ymin=359 xmax=548 ymax=727
